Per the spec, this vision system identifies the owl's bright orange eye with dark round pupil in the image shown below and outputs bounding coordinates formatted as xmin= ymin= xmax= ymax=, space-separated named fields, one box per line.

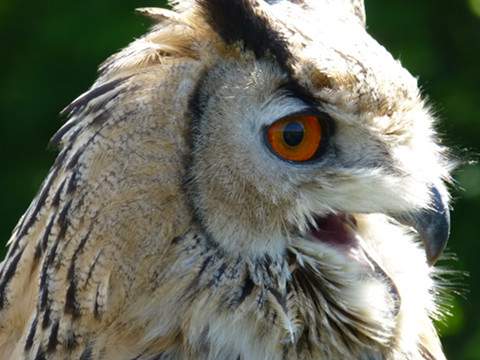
xmin=267 ymin=115 xmax=323 ymax=162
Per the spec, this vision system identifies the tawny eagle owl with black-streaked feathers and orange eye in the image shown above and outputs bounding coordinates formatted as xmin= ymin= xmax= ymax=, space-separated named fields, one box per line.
xmin=0 ymin=0 xmax=452 ymax=360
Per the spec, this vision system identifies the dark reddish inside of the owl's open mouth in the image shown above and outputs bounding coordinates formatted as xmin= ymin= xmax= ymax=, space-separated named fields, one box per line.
xmin=310 ymin=215 xmax=357 ymax=247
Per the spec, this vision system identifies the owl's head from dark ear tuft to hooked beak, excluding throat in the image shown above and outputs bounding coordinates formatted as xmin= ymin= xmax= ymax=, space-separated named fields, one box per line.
xmin=99 ymin=0 xmax=451 ymax=258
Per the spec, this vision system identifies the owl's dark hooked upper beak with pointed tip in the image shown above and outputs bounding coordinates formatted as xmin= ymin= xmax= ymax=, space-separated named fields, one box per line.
xmin=393 ymin=187 xmax=450 ymax=266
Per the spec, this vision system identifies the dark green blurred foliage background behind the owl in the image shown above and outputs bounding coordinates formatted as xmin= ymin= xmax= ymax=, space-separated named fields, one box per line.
xmin=0 ymin=0 xmax=480 ymax=360
